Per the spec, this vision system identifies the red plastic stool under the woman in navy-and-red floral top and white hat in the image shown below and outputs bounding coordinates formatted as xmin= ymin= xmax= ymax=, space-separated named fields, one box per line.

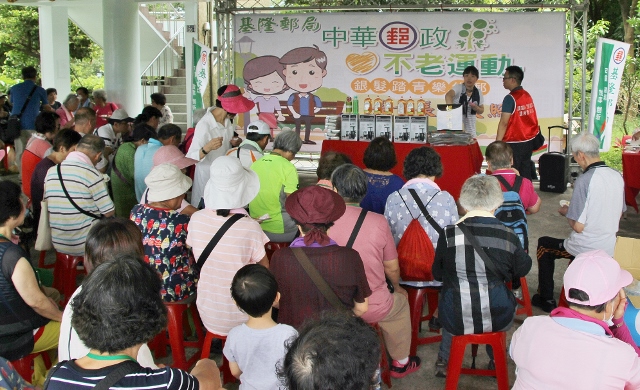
xmin=154 ymin=294 xmax=204 ymax=371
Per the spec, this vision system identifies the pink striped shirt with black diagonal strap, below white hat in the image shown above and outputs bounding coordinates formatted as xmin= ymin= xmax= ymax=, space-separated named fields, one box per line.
xmin=187 ymin=209 xmax=269 ymax=335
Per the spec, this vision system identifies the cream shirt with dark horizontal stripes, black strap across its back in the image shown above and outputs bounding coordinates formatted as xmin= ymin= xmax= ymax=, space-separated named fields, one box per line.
xmin=44 ymin=152 xmax=113 ymax=256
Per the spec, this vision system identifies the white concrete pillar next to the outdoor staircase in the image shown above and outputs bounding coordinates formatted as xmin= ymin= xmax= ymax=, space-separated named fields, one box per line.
xmin=102 ymin=0 xmax=143 ymax=117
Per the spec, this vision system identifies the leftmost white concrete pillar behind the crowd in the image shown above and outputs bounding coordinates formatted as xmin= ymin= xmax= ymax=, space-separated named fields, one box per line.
xmin=38 ymin=5 xmax=71 ymax=96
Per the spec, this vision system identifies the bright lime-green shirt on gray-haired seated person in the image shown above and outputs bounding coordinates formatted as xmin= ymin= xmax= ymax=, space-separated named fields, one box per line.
xmin=249 ymin=154 xmax=298 ymax=234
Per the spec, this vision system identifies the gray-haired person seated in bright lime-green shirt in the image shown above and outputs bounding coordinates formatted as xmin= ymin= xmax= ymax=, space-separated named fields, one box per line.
xmin=249 ymin=131 xmax=302 ymax=242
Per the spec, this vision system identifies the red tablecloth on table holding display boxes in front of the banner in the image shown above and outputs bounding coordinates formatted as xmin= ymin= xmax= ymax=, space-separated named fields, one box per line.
xmin=322 ymin=140 xmax=483 ymax=200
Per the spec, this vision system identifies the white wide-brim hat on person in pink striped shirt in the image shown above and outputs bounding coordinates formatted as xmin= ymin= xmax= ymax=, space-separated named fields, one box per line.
xmin=203 ymin=156 xmax=260 ymax=210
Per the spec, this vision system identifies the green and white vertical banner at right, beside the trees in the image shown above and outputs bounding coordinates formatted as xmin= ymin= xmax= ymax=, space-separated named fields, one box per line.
xmin=588 ymin=38 xmax=629 ymax=152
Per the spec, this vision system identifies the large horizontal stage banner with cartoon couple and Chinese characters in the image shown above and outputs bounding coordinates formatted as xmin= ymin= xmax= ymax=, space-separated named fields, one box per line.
xmin=234 ymin=12 xmax=566 ymax=143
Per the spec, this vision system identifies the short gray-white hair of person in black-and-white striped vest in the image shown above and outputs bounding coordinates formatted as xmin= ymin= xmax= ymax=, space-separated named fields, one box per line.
xmin=460 ymin=175 xmax=504 ymax=212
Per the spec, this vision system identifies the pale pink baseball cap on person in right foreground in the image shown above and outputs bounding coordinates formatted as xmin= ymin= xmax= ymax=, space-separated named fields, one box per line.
xmin=564 ymin=250 xmax=633 ymax=306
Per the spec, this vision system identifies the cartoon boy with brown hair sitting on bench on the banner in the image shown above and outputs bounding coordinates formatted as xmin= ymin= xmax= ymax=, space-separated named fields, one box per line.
xmin=280 ymin=45 xmax=327 ymax=145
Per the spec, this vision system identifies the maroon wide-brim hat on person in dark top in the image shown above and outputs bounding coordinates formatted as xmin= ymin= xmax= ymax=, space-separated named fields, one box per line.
xmin=284 ymin=186 xmax=347 ymax=225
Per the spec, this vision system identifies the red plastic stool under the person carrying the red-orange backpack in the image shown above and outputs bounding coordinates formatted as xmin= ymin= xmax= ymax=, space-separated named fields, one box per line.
xmin=403 ymin=285 xmax=442 ymax=356
